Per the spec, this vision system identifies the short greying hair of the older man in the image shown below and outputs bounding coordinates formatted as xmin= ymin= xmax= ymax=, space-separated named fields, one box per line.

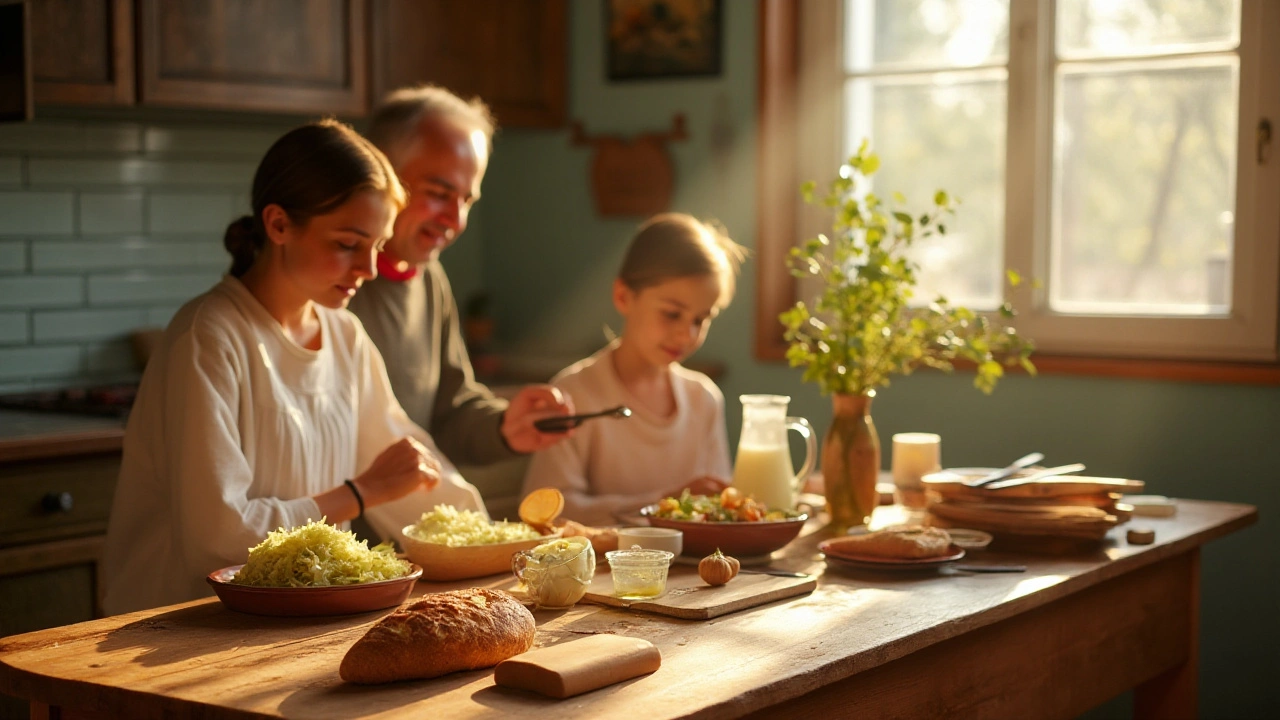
xmin=369 ymin=85 xmax=497 ymax=167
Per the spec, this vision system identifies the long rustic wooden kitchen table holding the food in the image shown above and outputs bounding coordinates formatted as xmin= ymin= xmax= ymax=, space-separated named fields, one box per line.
xmin=0 ymin=501 xmax=1257 ymax=720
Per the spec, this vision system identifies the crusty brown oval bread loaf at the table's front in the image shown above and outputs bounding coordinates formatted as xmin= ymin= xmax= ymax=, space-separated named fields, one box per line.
xmin=338 ymin=588 xmax=534 ymax=684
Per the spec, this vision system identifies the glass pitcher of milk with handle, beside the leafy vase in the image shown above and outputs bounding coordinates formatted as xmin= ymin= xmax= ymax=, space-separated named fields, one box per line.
xmin=732 ymin=395 xmax=818 ymax=510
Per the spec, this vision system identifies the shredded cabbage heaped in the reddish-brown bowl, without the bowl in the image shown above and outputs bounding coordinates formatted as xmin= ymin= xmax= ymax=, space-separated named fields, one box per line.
xmin=232 ymin=518 xmax=410 ymax=588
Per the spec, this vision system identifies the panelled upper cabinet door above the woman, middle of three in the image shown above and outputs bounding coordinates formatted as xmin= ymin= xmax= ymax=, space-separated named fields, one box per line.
xmin=138 ymin=0 xmax=369 ymax=115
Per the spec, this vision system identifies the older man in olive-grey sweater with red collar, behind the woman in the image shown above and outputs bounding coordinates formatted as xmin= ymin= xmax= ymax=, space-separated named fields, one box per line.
xmin=349 ymin=86 xmax=573 ymax=474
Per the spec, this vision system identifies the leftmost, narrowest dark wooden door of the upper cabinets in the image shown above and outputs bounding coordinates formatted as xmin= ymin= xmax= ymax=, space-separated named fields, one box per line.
xmin=31 ymin=0 xmax=134 ymax=105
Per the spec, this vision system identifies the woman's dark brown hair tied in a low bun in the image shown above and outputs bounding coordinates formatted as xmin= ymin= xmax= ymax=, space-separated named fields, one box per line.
xmin=223 ymin=119 xmax=404 ymax=278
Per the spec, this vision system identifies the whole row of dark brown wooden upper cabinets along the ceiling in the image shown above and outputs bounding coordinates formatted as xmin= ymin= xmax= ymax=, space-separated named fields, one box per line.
xmin=10 ymin=0 xmax=568 ymax=120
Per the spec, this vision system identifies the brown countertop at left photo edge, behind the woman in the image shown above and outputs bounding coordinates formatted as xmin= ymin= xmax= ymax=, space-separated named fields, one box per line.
xmin=0 ymin=410 xmax=124 ymax=462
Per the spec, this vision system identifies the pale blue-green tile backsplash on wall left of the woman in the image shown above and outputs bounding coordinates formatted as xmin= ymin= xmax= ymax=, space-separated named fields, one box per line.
xmin=0 ymin=118 xmax=292 ymax=392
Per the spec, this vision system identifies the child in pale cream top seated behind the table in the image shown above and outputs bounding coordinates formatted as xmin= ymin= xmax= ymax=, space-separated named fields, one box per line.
xmin=524 ymin=213 xmax=745 ymax=525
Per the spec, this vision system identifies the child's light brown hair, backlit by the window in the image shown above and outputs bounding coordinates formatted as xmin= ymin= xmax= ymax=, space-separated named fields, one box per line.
xmin=618 ymin=213 xmax=746 ymax=309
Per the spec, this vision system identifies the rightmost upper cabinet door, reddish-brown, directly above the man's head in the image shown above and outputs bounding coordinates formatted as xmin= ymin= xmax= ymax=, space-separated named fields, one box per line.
xmin=372 ymin=0 xmax=568 ymax=127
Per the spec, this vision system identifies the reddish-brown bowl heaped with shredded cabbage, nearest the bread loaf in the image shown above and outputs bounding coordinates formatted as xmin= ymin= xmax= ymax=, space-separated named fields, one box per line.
xmin=206 ymin=520 xmax=422 ymax=616
